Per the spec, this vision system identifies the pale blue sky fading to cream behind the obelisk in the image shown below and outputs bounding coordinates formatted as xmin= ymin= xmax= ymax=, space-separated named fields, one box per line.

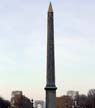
xmin=0 ymin=0 xmax=95 ymax=99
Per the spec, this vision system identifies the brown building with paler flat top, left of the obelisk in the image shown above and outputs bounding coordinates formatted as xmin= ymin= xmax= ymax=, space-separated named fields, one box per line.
xmin=11 ymin=91 xmax=33 ymax=108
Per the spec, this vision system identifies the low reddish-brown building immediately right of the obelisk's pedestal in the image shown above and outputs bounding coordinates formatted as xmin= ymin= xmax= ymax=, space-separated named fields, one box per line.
xmin=56 ymin=96 xmax=73 ymax=108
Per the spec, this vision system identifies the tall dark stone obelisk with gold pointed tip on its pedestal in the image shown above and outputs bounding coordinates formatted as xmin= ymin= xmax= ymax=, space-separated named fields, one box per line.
xmin=45 ymin=3 xmax=57 ymax=108
